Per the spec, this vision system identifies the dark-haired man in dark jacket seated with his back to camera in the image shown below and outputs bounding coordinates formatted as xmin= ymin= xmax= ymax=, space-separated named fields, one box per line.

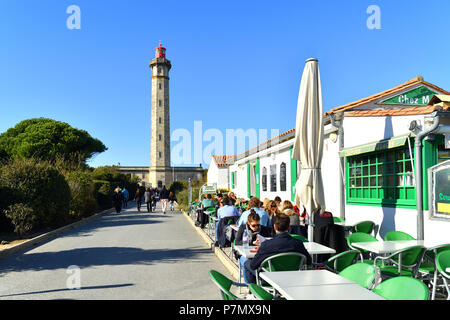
xmin=244 ymin=213 xmax=312 ymax=283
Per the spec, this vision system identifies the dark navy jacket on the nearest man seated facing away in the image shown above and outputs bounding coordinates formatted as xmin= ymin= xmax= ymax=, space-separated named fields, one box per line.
xmin=250 ymin=232 xmax=312 ymax=270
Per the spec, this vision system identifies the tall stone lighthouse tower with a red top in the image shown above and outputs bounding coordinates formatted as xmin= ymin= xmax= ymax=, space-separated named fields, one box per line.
xmin=149 ymin=44 xmax=173 ymax=188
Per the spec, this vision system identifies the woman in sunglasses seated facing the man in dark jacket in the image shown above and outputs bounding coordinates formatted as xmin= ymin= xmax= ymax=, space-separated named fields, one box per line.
xmin=235 ymin=209 xmax=273 ymax=283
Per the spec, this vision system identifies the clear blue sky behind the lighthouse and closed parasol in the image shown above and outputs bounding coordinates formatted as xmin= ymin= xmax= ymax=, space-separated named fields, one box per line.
xmin=0 ymin=0 xmax=450 ymax=167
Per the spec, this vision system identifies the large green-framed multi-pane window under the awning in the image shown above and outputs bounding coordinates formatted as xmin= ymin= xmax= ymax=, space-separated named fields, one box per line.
xmin=346 ymin=146 xmax=416 ymax=206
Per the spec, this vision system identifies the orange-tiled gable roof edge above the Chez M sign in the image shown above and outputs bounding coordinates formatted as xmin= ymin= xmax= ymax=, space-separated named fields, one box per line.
xmin=325 ymin=76 xmax=450 ymax=116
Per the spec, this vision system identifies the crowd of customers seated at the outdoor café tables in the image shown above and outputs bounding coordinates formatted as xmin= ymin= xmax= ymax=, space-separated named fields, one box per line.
xmin=192 ymin=192 xmax=311 ymax=283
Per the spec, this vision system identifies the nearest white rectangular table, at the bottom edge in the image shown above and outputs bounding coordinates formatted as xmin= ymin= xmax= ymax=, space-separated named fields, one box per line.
xmin=259 ymin=270 xmax=385 ymax=300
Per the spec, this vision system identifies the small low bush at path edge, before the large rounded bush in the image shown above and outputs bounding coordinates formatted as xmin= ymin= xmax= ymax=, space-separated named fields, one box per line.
xmin=4 ymin=203 xmax=38 ymax=236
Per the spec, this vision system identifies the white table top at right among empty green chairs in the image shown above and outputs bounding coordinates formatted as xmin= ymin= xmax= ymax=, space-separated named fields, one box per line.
xmin=352 ymin=240 xmax=445 ymax=254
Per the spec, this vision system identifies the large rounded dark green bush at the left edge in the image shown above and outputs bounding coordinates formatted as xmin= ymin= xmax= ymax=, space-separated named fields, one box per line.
xmin=0 ymin=159 xmax=71 ymax=228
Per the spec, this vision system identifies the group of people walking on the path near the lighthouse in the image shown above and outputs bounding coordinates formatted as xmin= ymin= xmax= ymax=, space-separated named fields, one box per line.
xmin=112 ymin=186 xmax=177 ymax=214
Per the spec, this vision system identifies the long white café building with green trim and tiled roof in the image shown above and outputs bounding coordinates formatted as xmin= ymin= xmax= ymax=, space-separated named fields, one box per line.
xmin=208 ymin=77 xmax=450 ymax=241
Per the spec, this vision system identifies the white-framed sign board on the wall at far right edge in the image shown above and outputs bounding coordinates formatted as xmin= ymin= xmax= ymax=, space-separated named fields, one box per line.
xmin=428 ymin=160 xmax=450 ymax=220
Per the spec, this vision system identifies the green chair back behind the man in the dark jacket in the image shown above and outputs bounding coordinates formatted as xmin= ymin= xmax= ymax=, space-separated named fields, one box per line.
xmin=256 ymin=252 xmax=306 ymax=285
